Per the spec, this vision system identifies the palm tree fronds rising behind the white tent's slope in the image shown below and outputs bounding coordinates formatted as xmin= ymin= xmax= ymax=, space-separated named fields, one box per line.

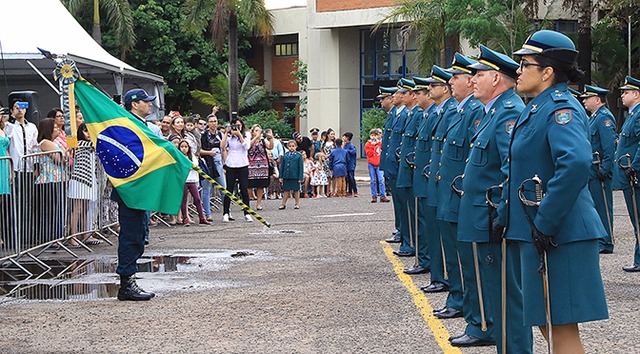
xmin=63 ymin=0 xmax=136 ymax=60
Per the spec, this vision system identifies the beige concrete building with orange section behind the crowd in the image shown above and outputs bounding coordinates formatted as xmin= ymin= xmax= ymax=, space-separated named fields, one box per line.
xmin=252 ymin=0 xmax=577 ymax=146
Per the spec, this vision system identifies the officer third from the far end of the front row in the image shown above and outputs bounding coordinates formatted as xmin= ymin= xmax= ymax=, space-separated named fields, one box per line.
xmin=396 ymin=80 xmax=430 ymax=274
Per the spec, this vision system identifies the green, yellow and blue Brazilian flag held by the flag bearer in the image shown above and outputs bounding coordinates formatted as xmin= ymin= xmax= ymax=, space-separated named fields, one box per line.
xmin=73 ymin=79 xmax=192 ymax=215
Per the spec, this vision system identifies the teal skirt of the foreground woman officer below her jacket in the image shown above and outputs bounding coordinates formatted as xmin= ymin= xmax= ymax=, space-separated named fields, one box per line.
xmin=520 ymin=239 xmax=609 ymax=326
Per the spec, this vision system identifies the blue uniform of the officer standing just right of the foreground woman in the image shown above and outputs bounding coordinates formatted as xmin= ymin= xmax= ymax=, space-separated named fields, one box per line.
xmin=589 ymin=106 xmax=616 ymax=252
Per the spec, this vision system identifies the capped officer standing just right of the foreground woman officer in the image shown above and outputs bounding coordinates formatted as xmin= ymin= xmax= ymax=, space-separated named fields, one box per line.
xmin=580 ymin=85 xmax=616 ymax=253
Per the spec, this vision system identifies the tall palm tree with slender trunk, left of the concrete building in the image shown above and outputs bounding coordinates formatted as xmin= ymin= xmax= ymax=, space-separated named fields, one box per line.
xmin=184 ymin=0 xmax=273 ymax=119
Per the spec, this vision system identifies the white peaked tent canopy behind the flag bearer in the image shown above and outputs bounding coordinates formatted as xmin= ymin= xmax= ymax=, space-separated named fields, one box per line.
xmin=0 ymin=0 xmax=164 ymax=119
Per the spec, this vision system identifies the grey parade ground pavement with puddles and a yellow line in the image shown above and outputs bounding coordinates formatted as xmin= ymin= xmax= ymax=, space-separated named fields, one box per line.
xmin=0 ymin=162 xmax=640 ymax=353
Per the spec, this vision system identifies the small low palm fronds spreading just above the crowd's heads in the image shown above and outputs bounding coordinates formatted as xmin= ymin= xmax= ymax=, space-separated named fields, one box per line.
xmin=191 ymin=70 xmax=267 ymax=112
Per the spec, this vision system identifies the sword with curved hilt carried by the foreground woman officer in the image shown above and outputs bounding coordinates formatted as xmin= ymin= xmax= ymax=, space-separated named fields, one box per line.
xmin=518 ymin=175 xmax=553 ymax=354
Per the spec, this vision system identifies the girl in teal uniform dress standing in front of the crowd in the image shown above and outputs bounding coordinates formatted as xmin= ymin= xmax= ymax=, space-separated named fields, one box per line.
xmin=278 ymin=140 xmax=304 ymax=210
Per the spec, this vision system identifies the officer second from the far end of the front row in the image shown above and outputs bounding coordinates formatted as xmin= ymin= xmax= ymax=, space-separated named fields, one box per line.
xmin=384 ymin=78 xmax=414 ymax=257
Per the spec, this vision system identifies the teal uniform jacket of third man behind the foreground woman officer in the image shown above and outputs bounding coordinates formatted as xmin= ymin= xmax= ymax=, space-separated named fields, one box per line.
xmin=427 ymin=97 xmax=458 ymax=207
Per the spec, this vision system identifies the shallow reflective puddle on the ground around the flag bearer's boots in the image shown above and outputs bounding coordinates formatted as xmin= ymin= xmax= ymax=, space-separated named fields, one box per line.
xmin=0 ymin=250 xmax=259 ymax=301
